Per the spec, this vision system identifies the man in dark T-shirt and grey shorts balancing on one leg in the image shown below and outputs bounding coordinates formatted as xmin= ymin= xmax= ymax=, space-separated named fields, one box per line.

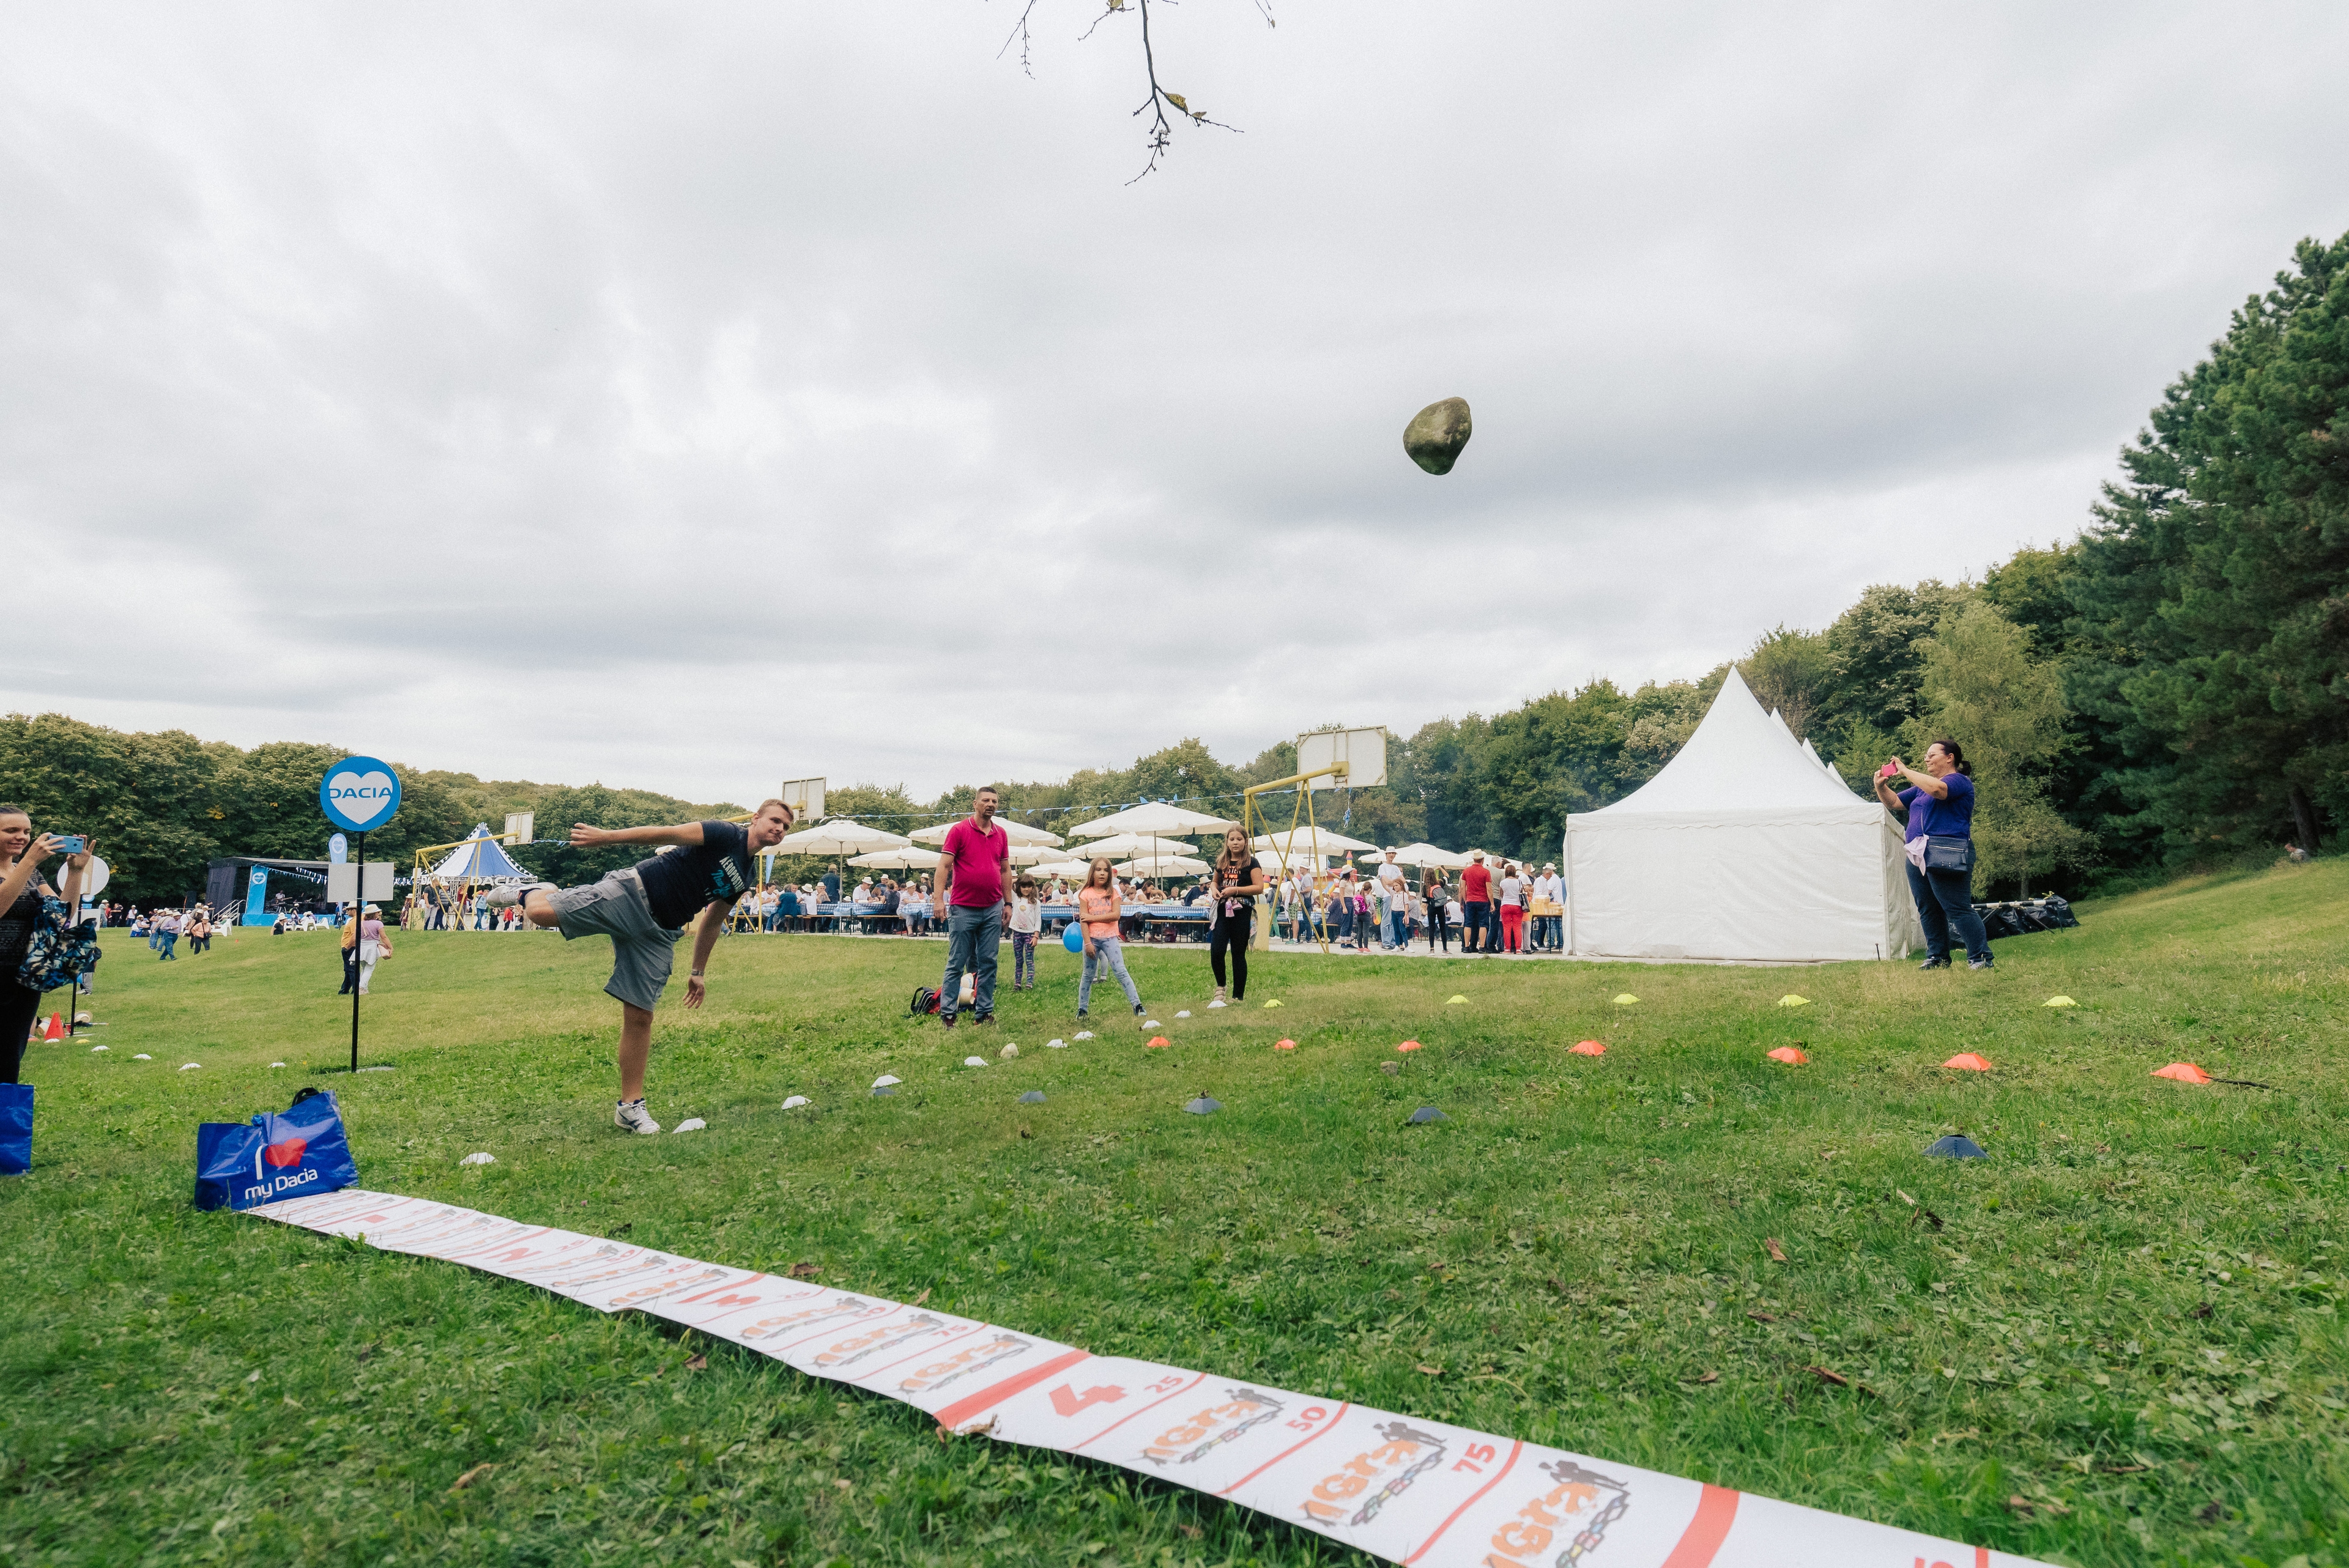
xmin=489 ymin=801 xmax=792 ymax=1131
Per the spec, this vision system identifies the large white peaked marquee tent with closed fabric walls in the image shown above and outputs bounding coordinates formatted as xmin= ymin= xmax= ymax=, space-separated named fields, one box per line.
xmin=1560 ymin=669 xmax=1924 ymax=963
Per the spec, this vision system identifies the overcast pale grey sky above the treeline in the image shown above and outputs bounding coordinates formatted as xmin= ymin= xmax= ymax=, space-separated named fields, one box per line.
xmin=13 ymin=0 xmax=2349 ymax=801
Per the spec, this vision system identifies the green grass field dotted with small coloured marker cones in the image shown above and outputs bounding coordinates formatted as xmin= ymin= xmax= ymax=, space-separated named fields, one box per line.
xmin=0 ymin=864 xmax=2349 ymax=1568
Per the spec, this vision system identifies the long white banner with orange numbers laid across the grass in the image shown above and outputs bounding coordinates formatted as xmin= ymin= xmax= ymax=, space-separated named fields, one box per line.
xmin=244 ymin=1188 xmax=2044 ymax=1568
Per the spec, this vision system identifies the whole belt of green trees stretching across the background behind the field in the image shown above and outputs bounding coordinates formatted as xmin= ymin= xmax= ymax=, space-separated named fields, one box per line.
xmin=0 ymin=235 xmax=2349 ymax=897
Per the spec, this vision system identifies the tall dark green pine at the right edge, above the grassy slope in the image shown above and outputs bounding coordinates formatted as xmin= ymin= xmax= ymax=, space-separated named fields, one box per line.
xmin=2067 ymin=235 xmax=2349 ymax=859
